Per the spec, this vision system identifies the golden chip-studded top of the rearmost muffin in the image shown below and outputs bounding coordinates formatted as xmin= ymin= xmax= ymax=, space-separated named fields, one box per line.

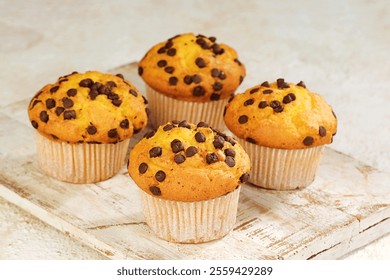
xmin=138 ymin=33 xmax=245 ymax=102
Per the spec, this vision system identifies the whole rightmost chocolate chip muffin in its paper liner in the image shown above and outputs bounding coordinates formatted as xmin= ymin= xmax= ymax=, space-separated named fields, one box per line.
xmin=224 ymin=79 xmax=337 ymax=190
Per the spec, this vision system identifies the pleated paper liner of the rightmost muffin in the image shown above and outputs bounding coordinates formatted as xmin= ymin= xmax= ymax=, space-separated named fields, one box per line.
xmin=238 ymin=139 xmax=325 ymax=191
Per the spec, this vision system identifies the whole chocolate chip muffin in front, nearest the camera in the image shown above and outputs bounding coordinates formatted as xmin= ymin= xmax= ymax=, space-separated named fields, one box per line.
xmin=128 ymin=121 xmax=250 ymax=243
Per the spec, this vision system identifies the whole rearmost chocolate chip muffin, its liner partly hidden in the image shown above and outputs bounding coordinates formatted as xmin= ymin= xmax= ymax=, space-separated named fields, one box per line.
xmin=138 ymin=33 xmax=245 ymax=129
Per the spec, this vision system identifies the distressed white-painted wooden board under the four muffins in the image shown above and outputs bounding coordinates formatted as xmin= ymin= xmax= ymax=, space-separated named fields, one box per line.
xmin=0 ymin=64 xmax=390 ymax=259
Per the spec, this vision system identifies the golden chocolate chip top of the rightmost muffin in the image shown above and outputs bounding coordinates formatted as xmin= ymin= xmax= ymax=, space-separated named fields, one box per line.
xmin=224 ymin=79 xmax=337 ymax=149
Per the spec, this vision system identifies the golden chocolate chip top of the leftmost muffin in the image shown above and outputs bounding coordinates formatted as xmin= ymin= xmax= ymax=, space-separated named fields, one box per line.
xmin=28 ymin=71 xmax=149 ymax=144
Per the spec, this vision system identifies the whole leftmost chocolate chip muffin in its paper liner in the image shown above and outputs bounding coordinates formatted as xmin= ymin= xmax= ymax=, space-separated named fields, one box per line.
xmin=28 ymin=71 xmax=148 ymax=183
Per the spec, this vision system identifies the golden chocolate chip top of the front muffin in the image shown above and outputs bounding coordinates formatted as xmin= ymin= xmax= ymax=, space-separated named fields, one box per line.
xmin=128 ymin=121 xmax=250 ymax=201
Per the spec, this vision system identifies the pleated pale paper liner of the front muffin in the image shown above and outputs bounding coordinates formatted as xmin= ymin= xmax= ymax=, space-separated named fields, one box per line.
xmin=141 ymin=187 xmax=240 ymax=243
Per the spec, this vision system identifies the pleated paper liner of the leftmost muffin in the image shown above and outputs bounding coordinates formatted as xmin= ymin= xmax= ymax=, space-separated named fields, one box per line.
xmin=36 ymin=132 xmax=130 ymax=183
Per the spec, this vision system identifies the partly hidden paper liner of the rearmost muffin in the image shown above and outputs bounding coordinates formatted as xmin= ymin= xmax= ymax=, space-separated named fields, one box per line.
xmin=146 ymin=85 xmax=227 ymax=130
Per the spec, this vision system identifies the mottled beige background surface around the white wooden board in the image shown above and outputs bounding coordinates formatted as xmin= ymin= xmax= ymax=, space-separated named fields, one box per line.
xmin=0 ymin=0 xmax=390 ymax=259
